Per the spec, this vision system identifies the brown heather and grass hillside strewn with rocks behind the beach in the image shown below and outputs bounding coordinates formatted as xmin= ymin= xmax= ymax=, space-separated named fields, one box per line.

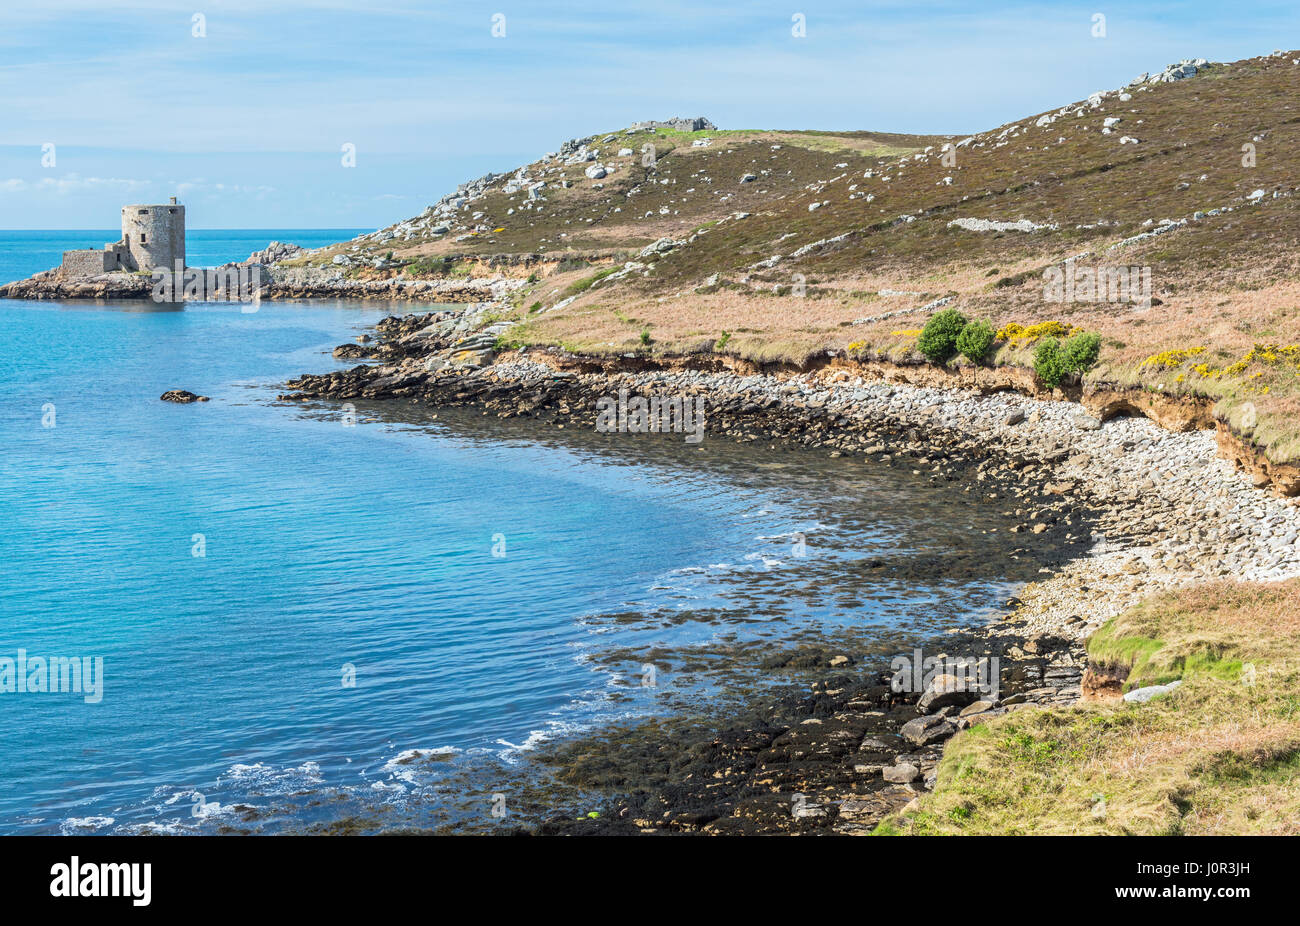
xmin=313 ymin=52 xmax=1300 ymax=462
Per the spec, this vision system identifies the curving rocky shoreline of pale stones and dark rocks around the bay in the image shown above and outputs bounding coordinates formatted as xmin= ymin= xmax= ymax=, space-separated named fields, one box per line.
xmin=281 ymin=306 xmax=1300 ymax=832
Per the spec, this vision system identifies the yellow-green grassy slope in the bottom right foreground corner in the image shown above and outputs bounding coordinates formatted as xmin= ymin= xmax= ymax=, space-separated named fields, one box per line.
xmin=880 ymin=581 xmax=1300 ymax=835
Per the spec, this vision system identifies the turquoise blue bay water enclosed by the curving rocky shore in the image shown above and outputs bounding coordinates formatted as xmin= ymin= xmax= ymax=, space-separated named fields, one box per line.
xmin=0 ymin=233 xmax=1019 ymax=832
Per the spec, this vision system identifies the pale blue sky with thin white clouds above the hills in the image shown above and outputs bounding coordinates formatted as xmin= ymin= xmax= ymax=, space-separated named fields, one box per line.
xmin=0 ymin=0 xmax=1300 ymax=229
